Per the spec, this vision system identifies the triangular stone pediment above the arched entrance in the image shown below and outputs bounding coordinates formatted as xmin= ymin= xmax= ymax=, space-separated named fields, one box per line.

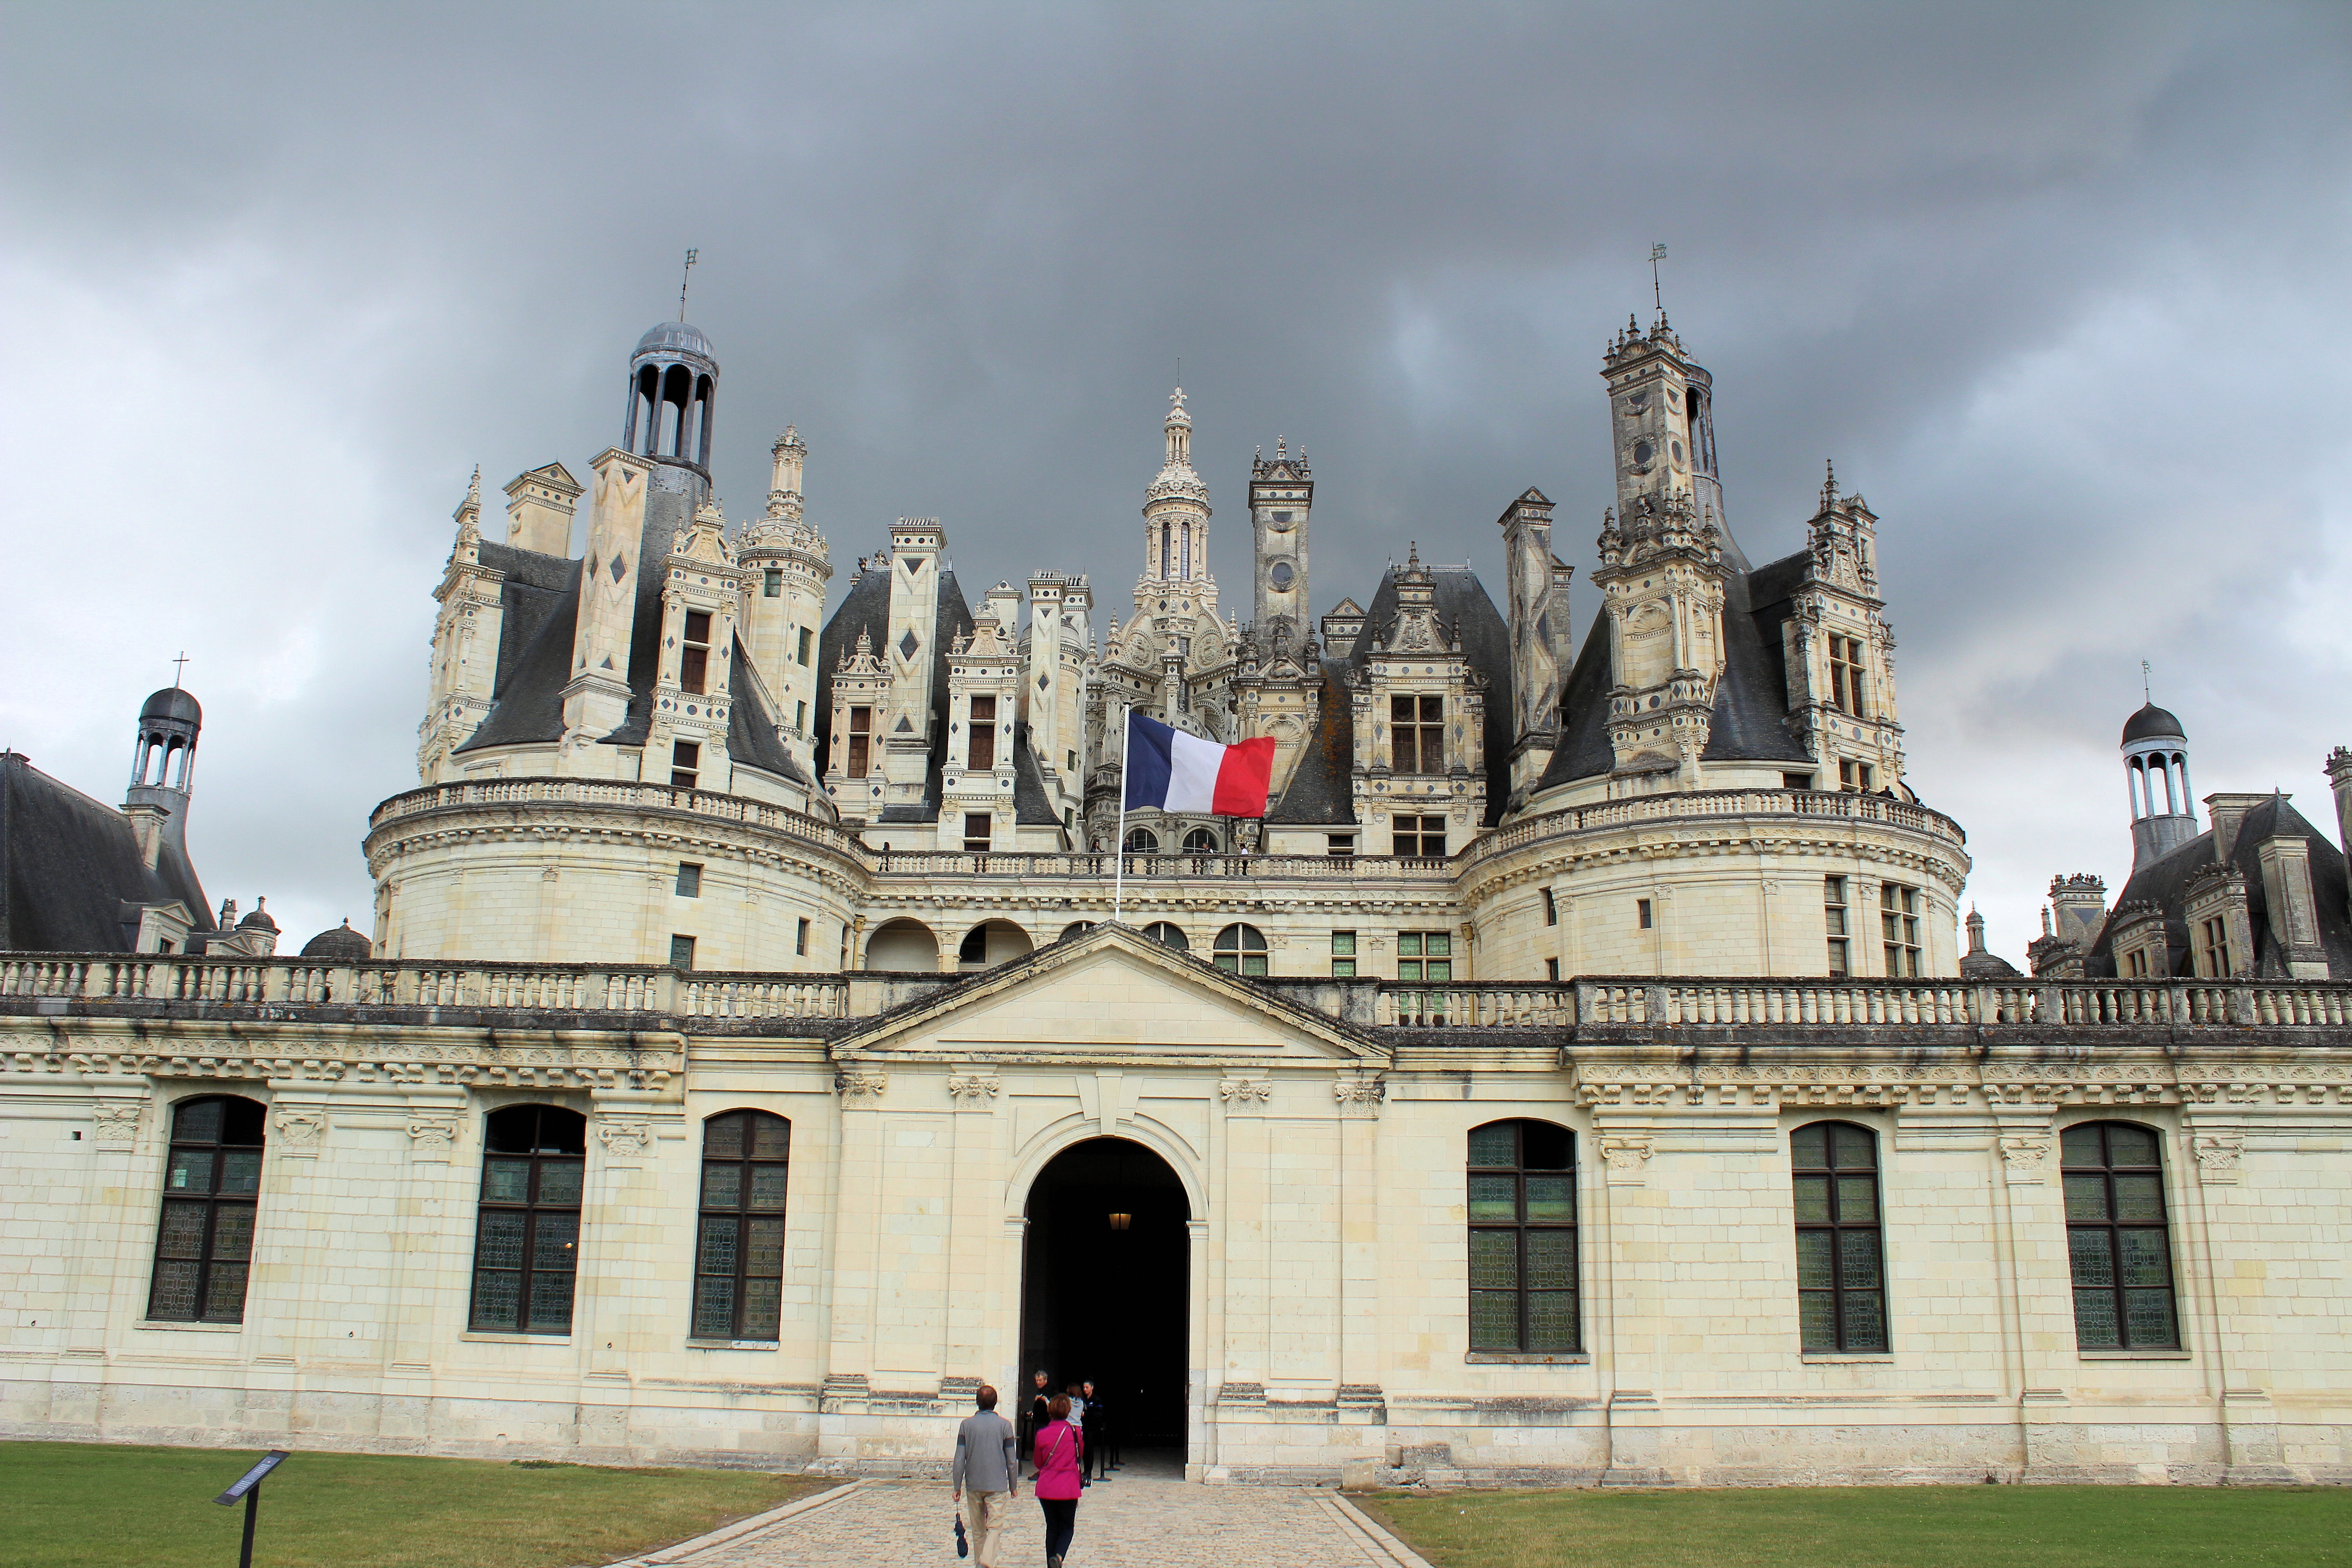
xmin=833 ymin=924 xmax=1388 ymax=1067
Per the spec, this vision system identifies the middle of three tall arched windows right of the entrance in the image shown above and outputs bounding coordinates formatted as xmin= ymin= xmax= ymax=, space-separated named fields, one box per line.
xmin=1788 ymin=1122 xmax=1886 ymax=1354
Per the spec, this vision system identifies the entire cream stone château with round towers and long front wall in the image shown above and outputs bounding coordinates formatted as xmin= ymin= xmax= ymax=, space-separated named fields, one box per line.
xmin=0 ymin=303 xmax=2352 ymax=1483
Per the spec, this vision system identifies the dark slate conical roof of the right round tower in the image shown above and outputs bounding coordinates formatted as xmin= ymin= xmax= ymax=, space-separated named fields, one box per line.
xmin=1534 ymin=536 xmax=1813 ymax=794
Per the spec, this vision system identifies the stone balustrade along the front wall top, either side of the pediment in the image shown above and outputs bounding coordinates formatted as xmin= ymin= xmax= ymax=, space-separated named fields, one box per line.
xmin=0 ymin=952 xmax=2352 ymax=1037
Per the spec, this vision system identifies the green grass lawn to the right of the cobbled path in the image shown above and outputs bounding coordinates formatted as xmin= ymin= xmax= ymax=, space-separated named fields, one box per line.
xmin=1357 ymin=1486 xmax=2352 ymax=1568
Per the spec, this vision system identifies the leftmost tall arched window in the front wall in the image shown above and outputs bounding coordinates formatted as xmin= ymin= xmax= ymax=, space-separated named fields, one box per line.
xmin=148 ymin=1096 xmax=264 ymax=1323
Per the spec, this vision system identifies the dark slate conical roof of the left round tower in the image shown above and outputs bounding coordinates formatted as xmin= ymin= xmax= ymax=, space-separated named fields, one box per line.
xmin=456 ymin=522 xmax=809 ymax=783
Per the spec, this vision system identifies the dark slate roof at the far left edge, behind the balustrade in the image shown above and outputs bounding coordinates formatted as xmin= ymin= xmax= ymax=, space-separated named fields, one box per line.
xmin=0 ymin=752 xmax=212 ymax=952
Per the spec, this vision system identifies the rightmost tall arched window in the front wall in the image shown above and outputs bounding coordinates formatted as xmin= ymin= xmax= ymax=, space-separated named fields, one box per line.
xmin=2058 ymin=1122 xmax=2180 ymax=1349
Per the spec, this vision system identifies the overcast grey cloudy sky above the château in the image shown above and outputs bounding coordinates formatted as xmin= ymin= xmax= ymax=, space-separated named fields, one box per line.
xmin=0 ymin=2 xmax=2352 ymax=961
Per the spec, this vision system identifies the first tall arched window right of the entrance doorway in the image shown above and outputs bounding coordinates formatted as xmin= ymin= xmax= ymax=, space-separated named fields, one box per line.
xmin=1470 ymin=1122 xmax=1581 ymax=1354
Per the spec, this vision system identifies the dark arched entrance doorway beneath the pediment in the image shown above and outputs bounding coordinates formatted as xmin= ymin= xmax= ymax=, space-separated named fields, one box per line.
xmin=1019 ymin=1138 xmax=1192 ymax=1450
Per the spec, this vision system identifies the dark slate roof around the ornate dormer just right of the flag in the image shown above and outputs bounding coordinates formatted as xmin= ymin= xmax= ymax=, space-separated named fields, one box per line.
xmin=1265 ymin=567 xmax=1512 ymax=828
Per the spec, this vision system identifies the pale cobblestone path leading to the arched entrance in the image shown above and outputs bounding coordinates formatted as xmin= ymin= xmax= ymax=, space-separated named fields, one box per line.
xmin=680 ymin=1467 xmax=1418 ymax=1568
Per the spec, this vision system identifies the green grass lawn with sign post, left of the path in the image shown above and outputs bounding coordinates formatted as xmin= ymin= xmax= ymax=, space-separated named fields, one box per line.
xmin=0 ymin=1443 xmax=833 ymax=1568
